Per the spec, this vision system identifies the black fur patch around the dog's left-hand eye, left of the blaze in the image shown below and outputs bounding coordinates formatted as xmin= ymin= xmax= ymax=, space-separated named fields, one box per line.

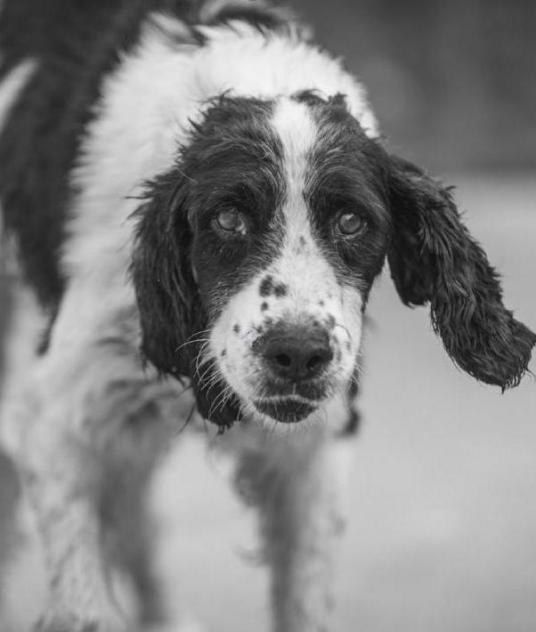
xmin=179 ymin=97 xmax=286 ymax=318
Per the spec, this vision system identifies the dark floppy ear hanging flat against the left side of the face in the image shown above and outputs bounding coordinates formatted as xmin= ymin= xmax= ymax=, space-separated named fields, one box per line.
xmin=131 ymin=173 xmax=240 ymax=428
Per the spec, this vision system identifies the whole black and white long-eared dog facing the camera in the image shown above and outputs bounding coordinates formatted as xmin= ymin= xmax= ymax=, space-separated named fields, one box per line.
xmin=0 ymin=0 xmax=536 ymax=632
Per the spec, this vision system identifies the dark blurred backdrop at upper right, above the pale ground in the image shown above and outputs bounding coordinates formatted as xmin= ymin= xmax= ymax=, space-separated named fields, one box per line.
xmin=293 ymin=0 xmax=536 ymax=171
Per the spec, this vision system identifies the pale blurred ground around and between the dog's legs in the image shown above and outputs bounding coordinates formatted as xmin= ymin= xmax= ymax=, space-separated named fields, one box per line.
xmin=0 ymin=177 xmax=536 ymax=632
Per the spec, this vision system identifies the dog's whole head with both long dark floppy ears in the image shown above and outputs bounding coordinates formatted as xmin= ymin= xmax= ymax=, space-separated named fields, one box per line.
xmin=133 ymin=92 xmax=536 ymax=425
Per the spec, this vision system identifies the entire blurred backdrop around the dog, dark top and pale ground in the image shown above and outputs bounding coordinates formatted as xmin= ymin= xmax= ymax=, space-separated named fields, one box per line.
xmin=0 ymin=0 xmax=536 ymax=632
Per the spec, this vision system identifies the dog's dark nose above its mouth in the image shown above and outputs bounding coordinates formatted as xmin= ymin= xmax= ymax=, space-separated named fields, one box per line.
xmin=263 ymin=326 xmax=333 ymax=382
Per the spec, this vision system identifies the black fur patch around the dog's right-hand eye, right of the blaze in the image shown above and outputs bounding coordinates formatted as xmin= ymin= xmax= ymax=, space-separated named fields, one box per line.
xmin=300 ymin=91 xmax=391 ymax=302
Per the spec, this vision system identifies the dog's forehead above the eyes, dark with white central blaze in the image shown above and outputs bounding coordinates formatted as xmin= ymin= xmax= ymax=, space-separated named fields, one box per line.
xmin=183 ymin=91 xmax=372 ymax=201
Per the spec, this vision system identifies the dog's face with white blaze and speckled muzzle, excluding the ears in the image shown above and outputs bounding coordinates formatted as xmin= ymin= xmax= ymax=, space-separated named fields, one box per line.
xmin=185 ymin=95 xmax=389 ymax=422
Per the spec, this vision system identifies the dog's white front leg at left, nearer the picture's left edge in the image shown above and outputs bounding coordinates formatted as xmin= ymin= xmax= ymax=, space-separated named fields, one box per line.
xmin=16 ymin=354 xmax=131 ymax=632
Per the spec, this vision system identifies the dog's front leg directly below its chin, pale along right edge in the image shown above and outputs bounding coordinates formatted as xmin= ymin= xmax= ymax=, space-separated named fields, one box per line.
xmin=237 ymin=429 xmax=351 ymax=632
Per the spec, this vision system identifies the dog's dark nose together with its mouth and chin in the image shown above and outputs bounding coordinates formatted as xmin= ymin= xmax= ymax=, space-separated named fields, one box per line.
xmin=254 ymin=322 xmax=333 ymax=423
